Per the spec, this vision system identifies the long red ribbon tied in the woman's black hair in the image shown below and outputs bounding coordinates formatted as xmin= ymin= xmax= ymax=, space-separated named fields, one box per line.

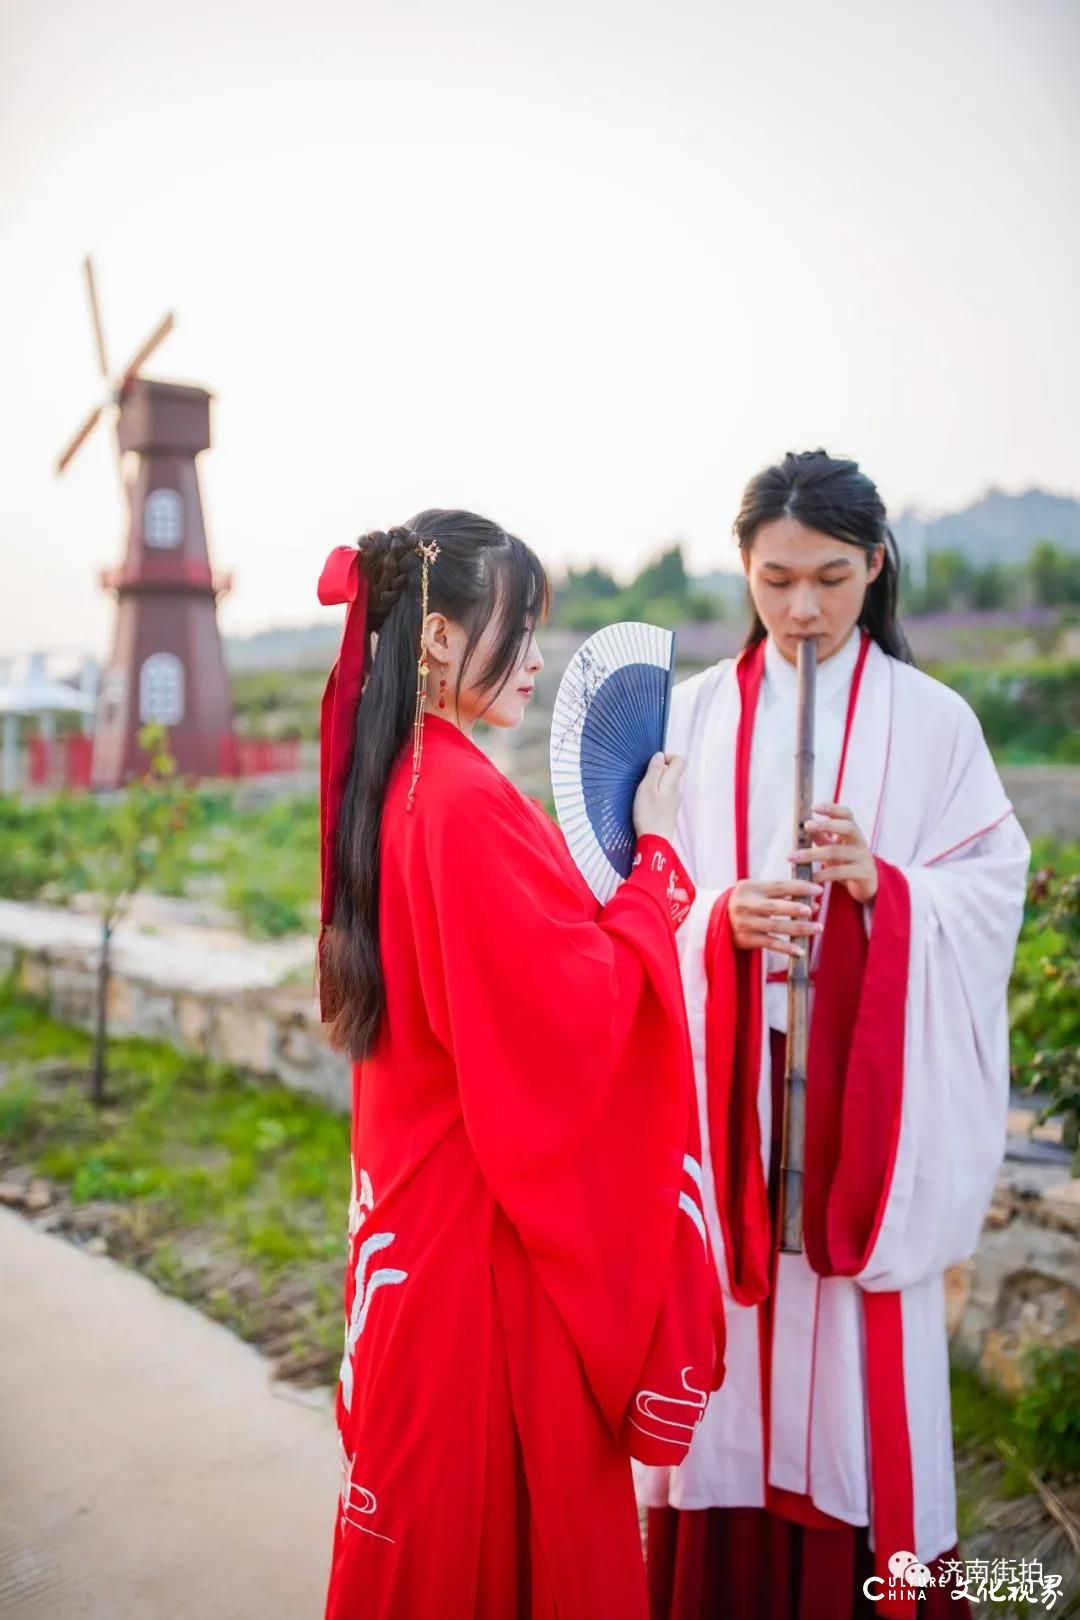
xmin=319 ymin=546 xmax=368 ymax=1019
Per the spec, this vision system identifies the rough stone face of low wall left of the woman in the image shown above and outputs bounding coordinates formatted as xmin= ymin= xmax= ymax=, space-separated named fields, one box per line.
xmin=0 ymin=941 xmax=351 ymax=1111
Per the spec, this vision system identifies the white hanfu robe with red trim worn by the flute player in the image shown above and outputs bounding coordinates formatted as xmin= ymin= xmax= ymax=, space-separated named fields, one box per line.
xmin=640 ymin=635 xmax=1030 ymax=1612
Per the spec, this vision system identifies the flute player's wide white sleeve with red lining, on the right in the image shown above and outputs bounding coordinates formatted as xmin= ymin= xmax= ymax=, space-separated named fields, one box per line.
xmin=805 ymin=813 xmax=1028 ymax=1291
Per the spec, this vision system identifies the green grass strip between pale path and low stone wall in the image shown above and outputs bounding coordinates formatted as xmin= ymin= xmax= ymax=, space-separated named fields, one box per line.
xmin=0 ymin=987 xmax=350 ymax=1380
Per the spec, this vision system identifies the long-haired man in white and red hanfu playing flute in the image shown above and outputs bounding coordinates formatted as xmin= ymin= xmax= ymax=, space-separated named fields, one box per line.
xmin=640 ymin=452 xmax=1028 ymax=1620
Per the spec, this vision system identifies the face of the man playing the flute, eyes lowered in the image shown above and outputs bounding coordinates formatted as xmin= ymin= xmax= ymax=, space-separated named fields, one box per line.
xmin=743 ymin=517 xmax=886 ymax=664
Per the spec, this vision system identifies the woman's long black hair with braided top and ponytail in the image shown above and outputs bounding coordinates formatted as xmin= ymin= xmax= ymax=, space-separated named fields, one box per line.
xmin=321 ymin=509 xmax=547 ymax=1058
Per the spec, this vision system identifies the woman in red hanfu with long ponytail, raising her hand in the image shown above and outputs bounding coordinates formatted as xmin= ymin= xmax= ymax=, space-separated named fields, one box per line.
xmin=319 ymin=512 xmax=722 ymax=1620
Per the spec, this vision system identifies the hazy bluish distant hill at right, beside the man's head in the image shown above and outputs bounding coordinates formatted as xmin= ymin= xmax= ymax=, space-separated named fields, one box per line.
xmin=892 ymin=489 xmax=1080 ymax=567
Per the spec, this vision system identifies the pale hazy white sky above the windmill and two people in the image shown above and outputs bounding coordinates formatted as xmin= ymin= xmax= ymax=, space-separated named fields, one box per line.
xmin=0 ymin=0 xmax=1080 ymax=658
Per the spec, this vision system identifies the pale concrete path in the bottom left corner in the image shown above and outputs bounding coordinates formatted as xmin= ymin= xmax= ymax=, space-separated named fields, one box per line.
xmin=0 ymin=1210 xmax=337 ymax=1620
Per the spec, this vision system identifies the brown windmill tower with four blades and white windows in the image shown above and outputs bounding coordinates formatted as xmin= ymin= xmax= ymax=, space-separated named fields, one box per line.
xmin=57 ymin=258 xmax=233 ymax=787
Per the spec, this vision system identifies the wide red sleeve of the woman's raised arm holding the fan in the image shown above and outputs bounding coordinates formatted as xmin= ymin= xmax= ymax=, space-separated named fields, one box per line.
xmin=426 ymin=784 xmax=714 ymax=1451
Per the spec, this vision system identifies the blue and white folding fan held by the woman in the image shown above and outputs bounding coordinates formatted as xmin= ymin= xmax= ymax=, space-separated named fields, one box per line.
xmin=551 ymin=624 xmax=675 ymax=904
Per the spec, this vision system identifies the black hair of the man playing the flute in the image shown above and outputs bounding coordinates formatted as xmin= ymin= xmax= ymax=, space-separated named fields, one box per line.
xmin=735 ymin=450 xmax=913 ymax=664
